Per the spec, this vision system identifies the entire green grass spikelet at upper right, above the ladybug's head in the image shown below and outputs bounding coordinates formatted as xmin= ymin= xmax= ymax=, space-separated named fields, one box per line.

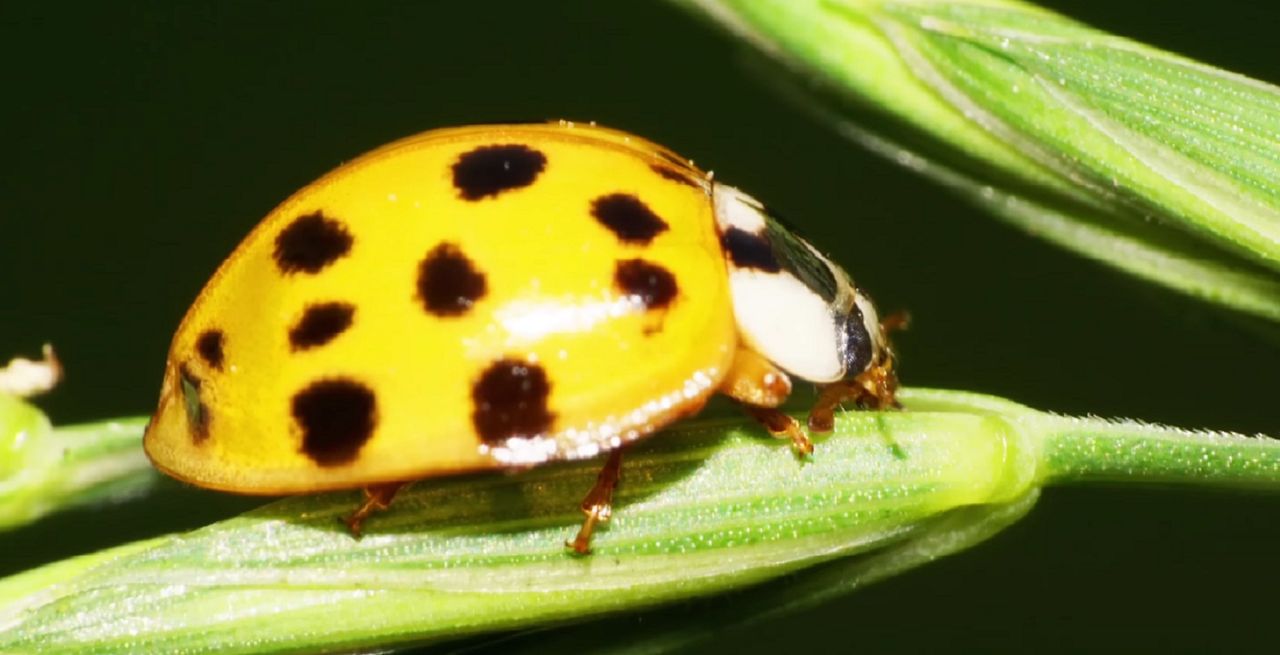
xmin=681 ymin=0 xmax=1280 ymax=321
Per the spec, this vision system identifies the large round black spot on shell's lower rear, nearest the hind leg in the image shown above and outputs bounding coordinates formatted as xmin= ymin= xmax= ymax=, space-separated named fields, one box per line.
xmin=292 ymin=377 xmax=378 ymax=466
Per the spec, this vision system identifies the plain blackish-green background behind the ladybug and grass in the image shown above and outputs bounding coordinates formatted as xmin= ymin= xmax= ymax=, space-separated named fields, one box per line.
xmin=0 ymin=0 xmax=1280 ymax=652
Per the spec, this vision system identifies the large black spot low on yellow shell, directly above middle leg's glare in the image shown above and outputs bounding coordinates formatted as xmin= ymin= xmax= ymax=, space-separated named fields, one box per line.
xmin=471 ymin=358 xmax=556 ymax=445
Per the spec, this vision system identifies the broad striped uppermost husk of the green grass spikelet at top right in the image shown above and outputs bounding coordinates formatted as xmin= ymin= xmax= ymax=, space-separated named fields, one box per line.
xmin=875 ymin=3 xmax=1280 ymax=264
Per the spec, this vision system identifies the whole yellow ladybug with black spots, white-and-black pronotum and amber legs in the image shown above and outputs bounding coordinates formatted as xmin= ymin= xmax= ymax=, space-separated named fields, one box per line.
xmin=145 ymin=122 xmax=896 ymax=553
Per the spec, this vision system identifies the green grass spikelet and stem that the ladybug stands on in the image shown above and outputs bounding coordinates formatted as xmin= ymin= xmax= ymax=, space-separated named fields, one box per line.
xmin=0 ymin=389 xmax=1280 ymax=652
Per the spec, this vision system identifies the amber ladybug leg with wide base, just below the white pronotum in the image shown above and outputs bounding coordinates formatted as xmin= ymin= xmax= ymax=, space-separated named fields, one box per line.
xmin=721 ymin=348 xmax=813 ymax=455
